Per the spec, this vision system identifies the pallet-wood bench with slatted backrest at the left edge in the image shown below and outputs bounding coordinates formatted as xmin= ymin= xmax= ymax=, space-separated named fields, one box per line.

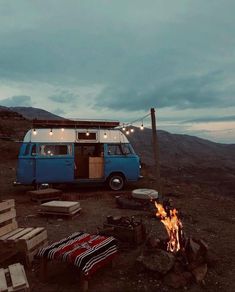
xmin=0 ymin=200 xmax=47 ymax=266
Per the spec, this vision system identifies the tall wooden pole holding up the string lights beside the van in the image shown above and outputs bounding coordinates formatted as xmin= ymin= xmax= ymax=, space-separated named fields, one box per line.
xmin=151 ymin=108 xmax=162 ymax=196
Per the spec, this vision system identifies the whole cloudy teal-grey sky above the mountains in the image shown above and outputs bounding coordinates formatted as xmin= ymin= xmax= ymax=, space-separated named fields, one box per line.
xmin=0 ymin=0 xmax=235 ymax=143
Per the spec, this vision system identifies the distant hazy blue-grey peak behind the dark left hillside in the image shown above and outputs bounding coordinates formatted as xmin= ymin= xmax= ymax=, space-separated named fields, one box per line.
xmin=9 ymin=106 xmax=64 ymax=120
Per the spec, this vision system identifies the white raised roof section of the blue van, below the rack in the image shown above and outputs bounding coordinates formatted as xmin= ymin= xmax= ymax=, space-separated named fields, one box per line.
xmin=23 ymin=128 xmax=129 ymax=143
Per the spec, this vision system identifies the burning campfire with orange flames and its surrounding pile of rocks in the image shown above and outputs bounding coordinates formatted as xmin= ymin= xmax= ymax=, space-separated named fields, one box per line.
xmin=138 ymin=202 xmax=209 ymax=288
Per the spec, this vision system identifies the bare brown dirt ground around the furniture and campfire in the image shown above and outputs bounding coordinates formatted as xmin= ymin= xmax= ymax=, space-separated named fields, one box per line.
xmin=0 ymin=160 xmax=235 ymax=292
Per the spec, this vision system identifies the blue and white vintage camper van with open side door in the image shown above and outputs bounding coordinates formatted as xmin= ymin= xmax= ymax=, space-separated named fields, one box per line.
xmin=15 ymin=128 xmax=141 ymax=191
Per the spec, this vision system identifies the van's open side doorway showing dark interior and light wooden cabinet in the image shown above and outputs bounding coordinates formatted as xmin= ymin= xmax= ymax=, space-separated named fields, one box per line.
xmin=74 ymin=143 xmax=104 ymax=179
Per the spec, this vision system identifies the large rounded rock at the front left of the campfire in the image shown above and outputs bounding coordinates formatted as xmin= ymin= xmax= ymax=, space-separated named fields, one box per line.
xmin=142 ymin=249 xmax=175 ymax=274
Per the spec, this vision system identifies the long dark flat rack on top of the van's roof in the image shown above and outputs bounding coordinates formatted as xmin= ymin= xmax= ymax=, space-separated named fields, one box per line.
xmin=32 ymin=119 xmax=120 ymax=129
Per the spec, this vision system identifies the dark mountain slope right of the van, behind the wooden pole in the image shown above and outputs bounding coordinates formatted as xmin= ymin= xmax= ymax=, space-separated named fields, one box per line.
xmin=128 ymin=128 xmax=235 ymax=196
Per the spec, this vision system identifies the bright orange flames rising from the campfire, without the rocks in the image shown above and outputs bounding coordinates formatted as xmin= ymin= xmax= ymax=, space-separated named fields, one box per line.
xmin=155 ymin=202 xmax=183 ymax=252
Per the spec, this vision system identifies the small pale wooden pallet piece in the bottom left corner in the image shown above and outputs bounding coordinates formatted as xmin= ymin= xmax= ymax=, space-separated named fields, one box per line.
xmin=0 ymin=263 xmax=30 ymax=292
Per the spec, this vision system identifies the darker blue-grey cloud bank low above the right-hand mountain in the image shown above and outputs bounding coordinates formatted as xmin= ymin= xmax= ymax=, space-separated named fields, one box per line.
xmin=95 ymin=71 xmax=235 ymax=111
